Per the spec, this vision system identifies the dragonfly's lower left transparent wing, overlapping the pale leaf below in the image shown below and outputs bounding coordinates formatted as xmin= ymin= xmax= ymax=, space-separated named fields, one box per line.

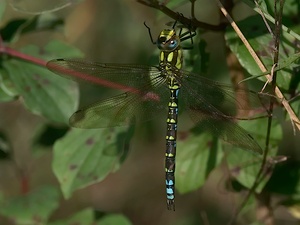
xmin=70 ymin=79 xmax=169 ymax=128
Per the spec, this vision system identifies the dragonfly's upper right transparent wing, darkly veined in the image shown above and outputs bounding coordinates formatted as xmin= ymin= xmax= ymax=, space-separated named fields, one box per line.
xmin=178 ymin=71 xmax=265 ymax=116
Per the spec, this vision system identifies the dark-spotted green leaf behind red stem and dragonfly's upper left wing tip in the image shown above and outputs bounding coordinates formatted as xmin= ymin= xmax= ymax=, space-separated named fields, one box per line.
xmin=3 ymin=41 xmax=81 ymax=124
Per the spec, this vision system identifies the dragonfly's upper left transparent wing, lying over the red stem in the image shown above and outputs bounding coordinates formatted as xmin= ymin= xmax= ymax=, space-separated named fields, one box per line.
xmin=47 ymin=59 xmax=160 ymax=91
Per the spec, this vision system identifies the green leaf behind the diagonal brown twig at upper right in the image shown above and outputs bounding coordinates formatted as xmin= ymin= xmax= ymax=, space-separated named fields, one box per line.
xmin=225 ymin=16 xmax=295 ymax=89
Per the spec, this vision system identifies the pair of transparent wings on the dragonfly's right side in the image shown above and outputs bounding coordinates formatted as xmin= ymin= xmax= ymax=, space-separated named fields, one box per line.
xmin=181 ymin=71 xmax=262 ymax=153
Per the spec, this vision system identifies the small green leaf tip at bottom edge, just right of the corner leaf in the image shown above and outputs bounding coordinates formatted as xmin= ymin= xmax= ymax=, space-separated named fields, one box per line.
xmin=48 ymin=209 xmax=95 ymax=225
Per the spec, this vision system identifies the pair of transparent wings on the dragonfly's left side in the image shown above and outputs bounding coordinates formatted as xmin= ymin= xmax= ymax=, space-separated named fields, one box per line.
xmin=47 ymin=59 xmax=169 ymax=128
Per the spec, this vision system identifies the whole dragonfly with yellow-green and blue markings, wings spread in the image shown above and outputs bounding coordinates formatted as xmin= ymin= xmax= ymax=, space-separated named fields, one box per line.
xmin=47 ymin=24 xmax=262 ymax=211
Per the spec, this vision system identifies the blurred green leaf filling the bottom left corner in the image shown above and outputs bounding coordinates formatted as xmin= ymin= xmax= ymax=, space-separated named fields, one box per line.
xmin=0 ymin=186 xmax=59 ymax=225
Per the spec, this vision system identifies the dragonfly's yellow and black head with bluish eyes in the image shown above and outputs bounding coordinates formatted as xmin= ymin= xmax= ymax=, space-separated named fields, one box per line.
xmin=156 ymin=29 xmax=180 ymax=52
